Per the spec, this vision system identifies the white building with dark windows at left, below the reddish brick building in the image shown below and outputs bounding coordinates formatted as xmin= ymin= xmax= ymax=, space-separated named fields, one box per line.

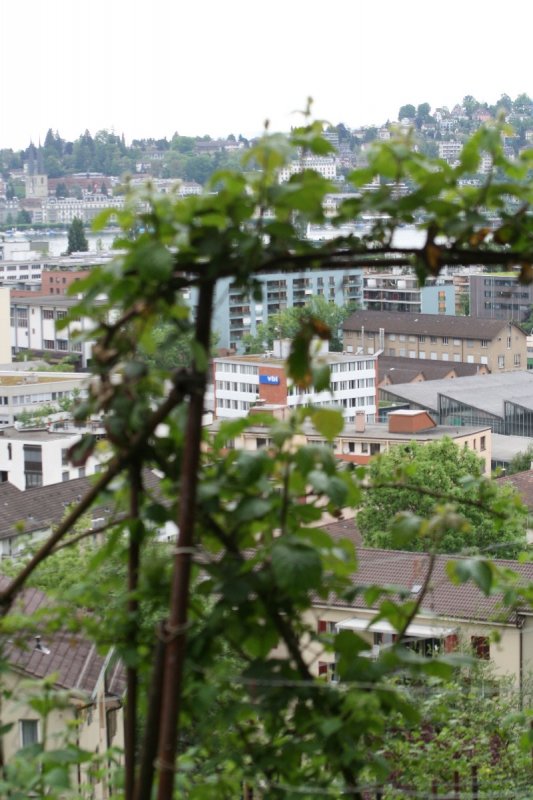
xmin=10 ymin=296 xmax=104 ymax=368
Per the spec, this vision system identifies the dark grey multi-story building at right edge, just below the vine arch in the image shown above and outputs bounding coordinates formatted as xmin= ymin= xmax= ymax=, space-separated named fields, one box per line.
xmin=470 ymin=272 xmax=533 ymax=322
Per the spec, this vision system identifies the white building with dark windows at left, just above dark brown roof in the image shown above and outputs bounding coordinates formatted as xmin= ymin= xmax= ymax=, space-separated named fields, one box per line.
xmin=0 ymin=424 xmax=103 ymax=490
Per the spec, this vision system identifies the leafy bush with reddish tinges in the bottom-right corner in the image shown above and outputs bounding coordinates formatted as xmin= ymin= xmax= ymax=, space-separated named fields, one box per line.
xmin=372 ymin=664 xmax=531 ymax=800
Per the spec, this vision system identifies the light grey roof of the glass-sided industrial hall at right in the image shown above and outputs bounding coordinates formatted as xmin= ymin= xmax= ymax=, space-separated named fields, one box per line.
xmin=382 ymin=370 xmax=533 ymax=419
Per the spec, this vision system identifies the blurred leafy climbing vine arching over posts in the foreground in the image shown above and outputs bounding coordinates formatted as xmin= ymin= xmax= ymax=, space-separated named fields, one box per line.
xmin=0 ymin=114 xmax=533 ymax=800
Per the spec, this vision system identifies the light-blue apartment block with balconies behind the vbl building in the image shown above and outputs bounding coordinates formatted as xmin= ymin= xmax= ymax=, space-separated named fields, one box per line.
xmin=210 ymin=268 xmax=363 ymax=350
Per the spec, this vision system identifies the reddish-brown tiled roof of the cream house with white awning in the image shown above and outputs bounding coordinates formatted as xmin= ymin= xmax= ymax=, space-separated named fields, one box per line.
xmin=316 ymin=547 xmax=533 ymax=625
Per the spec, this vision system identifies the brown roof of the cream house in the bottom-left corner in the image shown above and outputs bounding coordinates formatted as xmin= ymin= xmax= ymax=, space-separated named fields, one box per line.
xmin=0 ymin=575 xmax=124 ymax=695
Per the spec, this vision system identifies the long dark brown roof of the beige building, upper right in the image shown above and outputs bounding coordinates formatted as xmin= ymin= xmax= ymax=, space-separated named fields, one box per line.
xmin=343 ymin=310 xmax=525 ymax=340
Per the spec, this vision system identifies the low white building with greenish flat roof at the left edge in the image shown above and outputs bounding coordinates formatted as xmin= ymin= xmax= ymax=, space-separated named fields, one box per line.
xmin=0 ymin=370 xmax=87 ymax=428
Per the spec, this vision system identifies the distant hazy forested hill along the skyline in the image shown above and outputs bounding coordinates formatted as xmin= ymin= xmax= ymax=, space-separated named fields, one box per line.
xmin=0 ymin=94 xmax=533 ymax=188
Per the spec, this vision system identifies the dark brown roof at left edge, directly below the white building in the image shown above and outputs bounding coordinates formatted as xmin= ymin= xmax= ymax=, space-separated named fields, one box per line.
xmin=0 ymin=470 xmax=160 ymax=540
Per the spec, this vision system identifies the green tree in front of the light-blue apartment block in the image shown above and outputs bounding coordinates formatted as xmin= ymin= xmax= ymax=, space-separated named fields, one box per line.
xmin=243 ymin=295 xmax=357 ymax=353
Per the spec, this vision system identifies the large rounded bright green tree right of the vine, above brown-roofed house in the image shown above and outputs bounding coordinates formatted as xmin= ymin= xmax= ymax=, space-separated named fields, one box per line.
xmin=357 ymin=439 xmax=526 ymax=558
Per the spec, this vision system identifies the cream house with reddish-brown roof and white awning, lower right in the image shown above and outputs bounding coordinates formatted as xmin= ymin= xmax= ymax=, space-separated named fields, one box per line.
xmin=305 ymin=548 xmax=533 ymax=690
